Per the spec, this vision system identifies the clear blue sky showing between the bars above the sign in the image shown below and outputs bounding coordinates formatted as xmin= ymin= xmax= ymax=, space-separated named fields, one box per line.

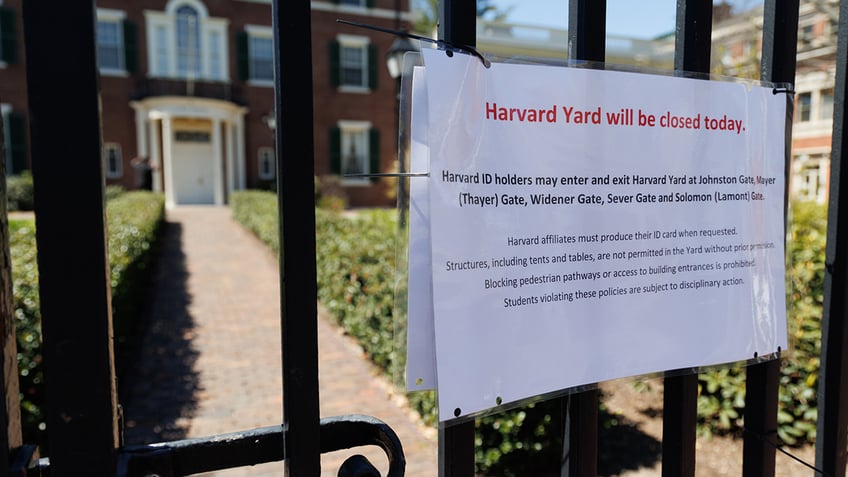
xmin=492 ymin=0 xmax=756 ymax=39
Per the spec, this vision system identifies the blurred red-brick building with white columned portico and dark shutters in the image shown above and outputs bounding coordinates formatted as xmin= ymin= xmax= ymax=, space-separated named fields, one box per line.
xmin=0 ymin=0 xmax=410 ymax=206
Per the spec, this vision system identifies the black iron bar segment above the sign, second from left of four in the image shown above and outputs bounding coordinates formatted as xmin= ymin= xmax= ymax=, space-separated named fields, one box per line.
xmin=568 ymin=0 xmax=607 ymax=61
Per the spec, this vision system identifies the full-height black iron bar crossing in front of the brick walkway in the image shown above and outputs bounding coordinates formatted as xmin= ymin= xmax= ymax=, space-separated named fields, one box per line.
xmin=272 ymin=0 xmax=321 ymax=477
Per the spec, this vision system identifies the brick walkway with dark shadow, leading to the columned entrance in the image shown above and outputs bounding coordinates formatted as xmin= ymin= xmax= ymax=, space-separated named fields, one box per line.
xmin=119 ymin=207 xmax=437 ymax=477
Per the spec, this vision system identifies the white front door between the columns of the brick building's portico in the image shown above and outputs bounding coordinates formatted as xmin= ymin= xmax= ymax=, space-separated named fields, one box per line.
xmin=172 ymin=130 xmax=215 ymax=204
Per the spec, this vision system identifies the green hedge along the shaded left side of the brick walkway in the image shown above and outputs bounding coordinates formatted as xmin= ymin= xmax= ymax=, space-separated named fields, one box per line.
xmin=9 ymin=192 xmax=165 ymax=443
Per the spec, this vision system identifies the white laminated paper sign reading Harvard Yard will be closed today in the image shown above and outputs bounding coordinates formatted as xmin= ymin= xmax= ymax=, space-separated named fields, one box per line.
xmin=413 ymin=50 xmax=787 ymax=420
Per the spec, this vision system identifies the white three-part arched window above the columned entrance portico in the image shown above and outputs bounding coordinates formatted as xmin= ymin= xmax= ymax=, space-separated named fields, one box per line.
xmin=144 ymin=0 xmax=230 ymax=82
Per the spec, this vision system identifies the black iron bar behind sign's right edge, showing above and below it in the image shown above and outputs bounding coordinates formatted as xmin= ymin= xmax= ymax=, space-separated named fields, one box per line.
xmin=742 ymin=0 xmax=800 ymax=477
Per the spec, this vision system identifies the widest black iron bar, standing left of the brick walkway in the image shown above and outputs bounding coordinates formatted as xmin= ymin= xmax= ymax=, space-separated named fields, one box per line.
xmin=23 ymin=0 xmax=118 ymax=476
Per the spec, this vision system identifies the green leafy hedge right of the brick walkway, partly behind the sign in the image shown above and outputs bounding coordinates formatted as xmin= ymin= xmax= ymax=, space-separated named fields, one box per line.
xmin=232 ymin=189 xmax=825 ymax=468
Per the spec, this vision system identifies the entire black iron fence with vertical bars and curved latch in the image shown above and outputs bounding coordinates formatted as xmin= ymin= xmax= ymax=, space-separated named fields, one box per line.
xmin=0 ymin=0 xmax=848 ymax=477
